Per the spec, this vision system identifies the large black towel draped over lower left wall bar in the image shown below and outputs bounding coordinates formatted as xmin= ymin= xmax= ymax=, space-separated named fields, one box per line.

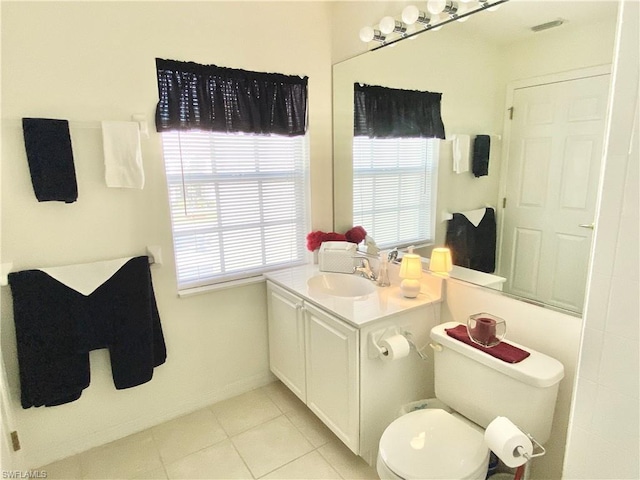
xmin=9 ymin=257 xmax=166 ymax=408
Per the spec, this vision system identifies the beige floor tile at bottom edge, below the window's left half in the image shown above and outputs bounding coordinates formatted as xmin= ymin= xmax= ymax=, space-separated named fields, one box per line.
xmin=167 ymin=440 xmax=253 ymax=480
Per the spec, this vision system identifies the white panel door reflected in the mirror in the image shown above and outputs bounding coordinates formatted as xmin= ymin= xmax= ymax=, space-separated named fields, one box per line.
xmin=501 ymin=75 xmax=609 ymax=312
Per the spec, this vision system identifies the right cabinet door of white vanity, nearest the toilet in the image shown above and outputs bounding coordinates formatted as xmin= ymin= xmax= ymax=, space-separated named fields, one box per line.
xmin=305 ymin=304 xmax=360 ymax=454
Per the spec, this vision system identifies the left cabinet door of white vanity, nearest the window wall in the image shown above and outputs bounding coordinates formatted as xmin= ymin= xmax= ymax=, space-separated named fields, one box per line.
xmin=267 ymin=282 xmax=306 ymax=402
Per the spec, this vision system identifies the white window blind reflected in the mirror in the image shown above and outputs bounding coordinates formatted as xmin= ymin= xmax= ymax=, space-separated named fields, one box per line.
xmin=353 ymin=136 xmax=438 ymax=248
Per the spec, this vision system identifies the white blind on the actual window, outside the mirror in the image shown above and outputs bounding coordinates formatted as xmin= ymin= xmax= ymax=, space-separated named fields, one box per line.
xmin=162 ymin=131 xmax=308 ymax=289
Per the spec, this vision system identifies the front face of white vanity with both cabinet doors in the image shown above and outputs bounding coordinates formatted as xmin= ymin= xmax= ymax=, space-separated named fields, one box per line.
xmin=267 ymin=282 xmax=360 ymax=453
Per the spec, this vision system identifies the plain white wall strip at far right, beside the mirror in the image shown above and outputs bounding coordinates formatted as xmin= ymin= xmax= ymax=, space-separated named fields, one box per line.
xmin=564 ymin=1 xmax=640 ymax=479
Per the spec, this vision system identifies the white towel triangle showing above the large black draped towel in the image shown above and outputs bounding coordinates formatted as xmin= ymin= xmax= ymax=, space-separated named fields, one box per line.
xmin=38 ymin=257 xmax=132 ymax=297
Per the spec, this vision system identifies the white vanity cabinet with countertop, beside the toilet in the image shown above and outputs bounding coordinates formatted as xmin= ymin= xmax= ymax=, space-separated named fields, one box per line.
xmin=265 ymin=265 xmax=442 ymax=465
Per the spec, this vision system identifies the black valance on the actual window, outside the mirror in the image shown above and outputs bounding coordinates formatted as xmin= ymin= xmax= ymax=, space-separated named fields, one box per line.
xmin=156 ymin=58 xmax=308 ymax=136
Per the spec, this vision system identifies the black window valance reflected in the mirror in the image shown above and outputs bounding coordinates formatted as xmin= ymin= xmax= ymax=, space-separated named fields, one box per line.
xmin=353 ymin=83 xmax=445 ymax=139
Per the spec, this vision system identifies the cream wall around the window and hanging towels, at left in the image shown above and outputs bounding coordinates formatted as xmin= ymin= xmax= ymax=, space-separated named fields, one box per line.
xmin=1 ymin=1 xmax=332 ymax=468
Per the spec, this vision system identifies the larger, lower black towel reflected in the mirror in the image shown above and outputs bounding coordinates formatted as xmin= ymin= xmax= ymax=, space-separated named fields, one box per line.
xmin=445 ymin=208 xmax=496 ymax=273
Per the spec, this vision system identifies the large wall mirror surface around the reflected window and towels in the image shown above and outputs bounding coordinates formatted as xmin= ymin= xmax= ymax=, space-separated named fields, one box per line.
xmin=333 ymin=0 xmax=617 ymax=314
